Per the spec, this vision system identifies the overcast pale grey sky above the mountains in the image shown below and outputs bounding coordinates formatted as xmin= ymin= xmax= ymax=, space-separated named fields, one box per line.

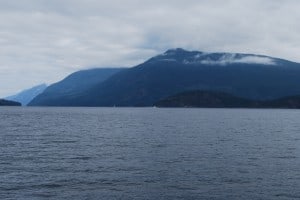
xmin=0 ymin=0 xmax=300 ymax=97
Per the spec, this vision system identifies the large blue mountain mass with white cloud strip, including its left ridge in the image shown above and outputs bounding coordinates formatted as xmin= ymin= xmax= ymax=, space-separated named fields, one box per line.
xmin=29 ymin=49 xmax=300 ymax=106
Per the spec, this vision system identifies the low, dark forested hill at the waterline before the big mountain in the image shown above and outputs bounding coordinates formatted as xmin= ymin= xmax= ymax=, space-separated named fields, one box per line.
xmin=154 ymin=91 xmax=300 ymax=108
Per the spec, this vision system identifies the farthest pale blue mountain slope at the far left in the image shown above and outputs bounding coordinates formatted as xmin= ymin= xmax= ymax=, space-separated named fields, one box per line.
xmin=5 ymin=84 xmax=47 ymax=106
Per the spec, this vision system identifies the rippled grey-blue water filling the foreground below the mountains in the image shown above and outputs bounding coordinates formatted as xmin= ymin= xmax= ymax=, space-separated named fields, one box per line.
xmin=0 ymin=108 xmax=300 ymax=199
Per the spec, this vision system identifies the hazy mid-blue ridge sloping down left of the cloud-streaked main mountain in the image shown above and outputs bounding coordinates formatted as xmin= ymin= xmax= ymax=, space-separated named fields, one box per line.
xmin=29 ymin=68 xmax=124 ymax=106
